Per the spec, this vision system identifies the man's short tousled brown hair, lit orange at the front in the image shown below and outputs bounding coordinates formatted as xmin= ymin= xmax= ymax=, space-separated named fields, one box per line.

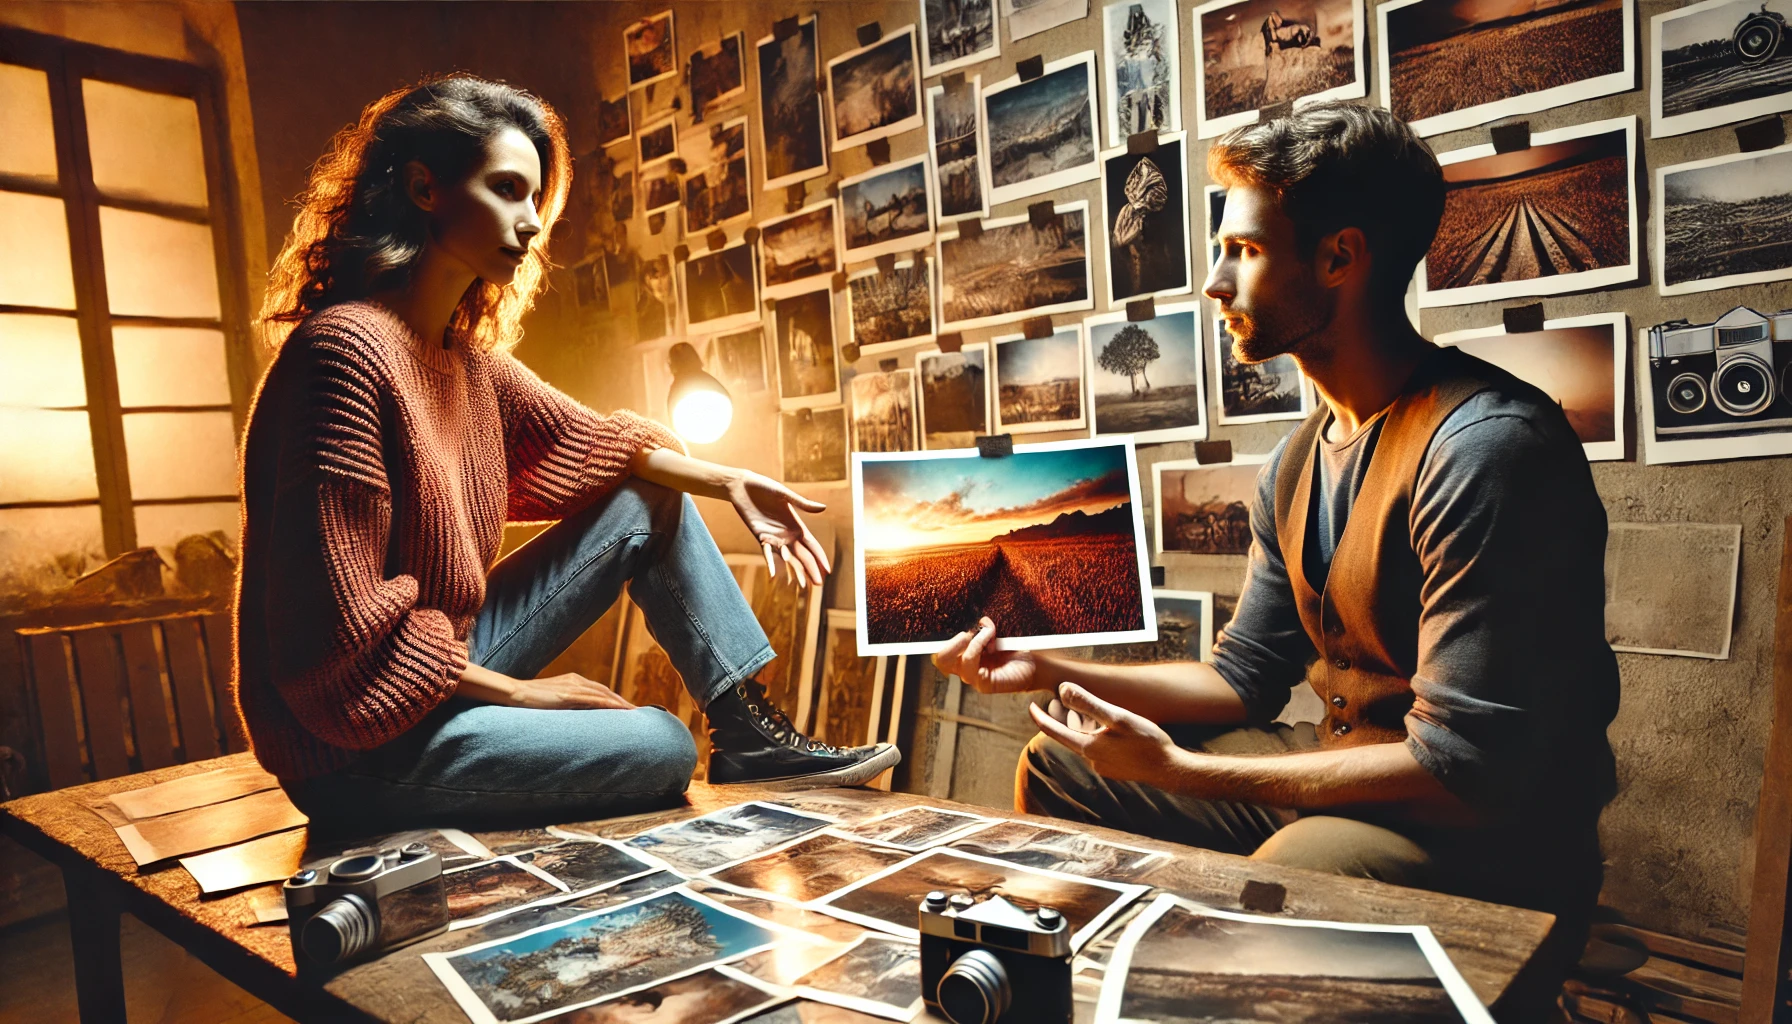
xmin=1208 ymin=102 xmax=1444 ymax=301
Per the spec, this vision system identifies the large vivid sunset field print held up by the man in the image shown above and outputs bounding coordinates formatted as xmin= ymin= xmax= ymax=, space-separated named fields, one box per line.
xmin=853 ymin=438 xmax=1158 ymax=655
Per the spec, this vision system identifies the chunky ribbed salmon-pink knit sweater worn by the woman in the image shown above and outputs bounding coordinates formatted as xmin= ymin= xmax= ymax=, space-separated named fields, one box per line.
xmin=235 ymin=301 xmax=681 ymax=782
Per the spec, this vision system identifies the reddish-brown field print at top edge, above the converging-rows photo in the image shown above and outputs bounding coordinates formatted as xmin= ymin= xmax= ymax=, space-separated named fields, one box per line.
xmin=1376 ymin=0 xmax=1636 ymax=135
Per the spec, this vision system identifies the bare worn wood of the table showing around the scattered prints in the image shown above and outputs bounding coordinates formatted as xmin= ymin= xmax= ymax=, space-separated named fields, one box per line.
xmin=0 ymin=753 xmax=1555 ymax=1024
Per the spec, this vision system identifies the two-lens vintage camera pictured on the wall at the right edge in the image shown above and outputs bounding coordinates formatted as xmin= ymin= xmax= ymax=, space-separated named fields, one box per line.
xmin=1649 ymin=307 xmax=1792 ymax=438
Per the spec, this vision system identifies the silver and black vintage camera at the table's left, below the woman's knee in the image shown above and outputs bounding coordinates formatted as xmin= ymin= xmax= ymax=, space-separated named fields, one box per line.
xmin=285 ymin=843 xmax=448 ymax=972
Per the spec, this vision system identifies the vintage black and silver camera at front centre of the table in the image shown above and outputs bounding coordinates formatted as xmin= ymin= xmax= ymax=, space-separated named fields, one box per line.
xmin=921 ymin=893 xmax=1073 ymax=1024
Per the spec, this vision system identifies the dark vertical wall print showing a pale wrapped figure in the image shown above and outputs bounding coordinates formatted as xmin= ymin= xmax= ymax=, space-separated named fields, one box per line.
xmin=1102 ymin=133 xmax=1193 ymax=307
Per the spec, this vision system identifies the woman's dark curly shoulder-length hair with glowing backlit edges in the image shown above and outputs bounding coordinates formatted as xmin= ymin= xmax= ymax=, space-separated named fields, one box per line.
xmin=260 ymin=74 xmax=572 ymax=351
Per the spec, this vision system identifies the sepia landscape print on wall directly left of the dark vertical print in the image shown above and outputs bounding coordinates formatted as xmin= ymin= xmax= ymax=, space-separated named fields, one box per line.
xmin=935 ymin=201 xmax=1095 ymax=330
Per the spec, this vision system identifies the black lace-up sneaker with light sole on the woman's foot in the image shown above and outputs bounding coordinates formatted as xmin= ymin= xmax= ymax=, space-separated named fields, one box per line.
xmin=704 ymin=680 xmax=901 ymax=789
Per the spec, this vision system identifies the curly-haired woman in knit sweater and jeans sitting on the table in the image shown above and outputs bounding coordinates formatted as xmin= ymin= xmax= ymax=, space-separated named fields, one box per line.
xmin=237 ymin=75 xmax=898 ymax=830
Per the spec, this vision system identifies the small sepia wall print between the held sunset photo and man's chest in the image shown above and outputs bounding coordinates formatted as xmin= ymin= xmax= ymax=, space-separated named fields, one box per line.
xmin=1150 ymin=452 xmax=1269 ymax=554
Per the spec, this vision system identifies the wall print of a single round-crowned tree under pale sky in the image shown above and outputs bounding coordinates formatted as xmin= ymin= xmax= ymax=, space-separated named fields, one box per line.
xmin=1082 ymin=303 xmax=1208 ymax=443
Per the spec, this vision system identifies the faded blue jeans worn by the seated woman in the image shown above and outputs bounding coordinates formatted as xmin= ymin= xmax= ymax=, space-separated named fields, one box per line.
xmin=287 ymin=477 xmax=772 ymax=834
